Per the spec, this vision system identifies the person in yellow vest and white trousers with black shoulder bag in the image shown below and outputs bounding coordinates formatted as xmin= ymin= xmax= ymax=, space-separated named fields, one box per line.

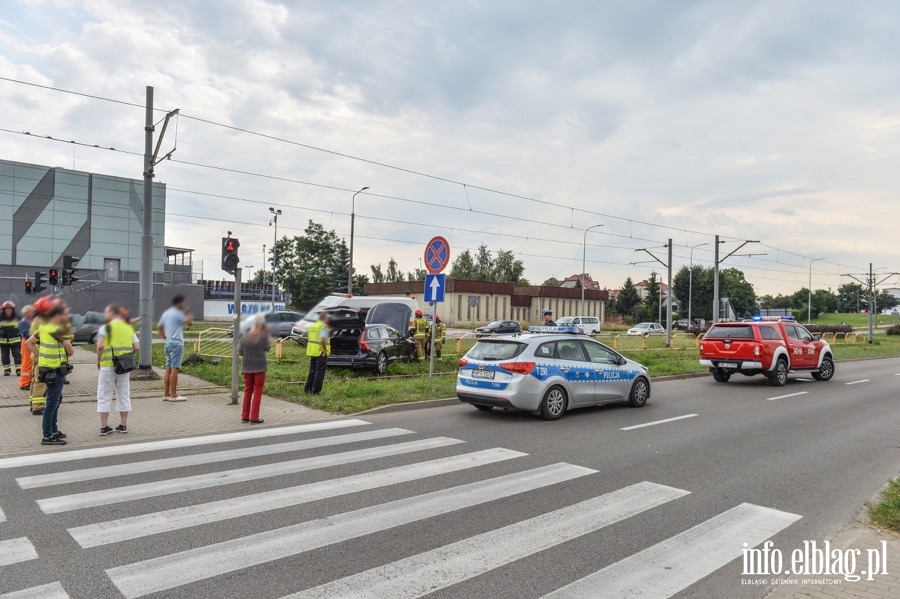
xmin=97 ymin=304 xmax=139 ymax=437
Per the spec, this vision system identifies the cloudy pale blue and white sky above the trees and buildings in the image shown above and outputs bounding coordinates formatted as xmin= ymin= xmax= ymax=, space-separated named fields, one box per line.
xmin=0 ymin=0 xmax=900 ymax=293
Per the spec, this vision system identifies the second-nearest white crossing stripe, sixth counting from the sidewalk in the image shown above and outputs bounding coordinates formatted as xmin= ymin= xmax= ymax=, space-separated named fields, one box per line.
xmin=283 ymin=482 xmax=689 ymax=599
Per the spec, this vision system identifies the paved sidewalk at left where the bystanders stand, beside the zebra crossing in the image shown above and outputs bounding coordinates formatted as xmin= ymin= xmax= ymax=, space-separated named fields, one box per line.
xmin=0 ymin=348 xmax=336 ymax=455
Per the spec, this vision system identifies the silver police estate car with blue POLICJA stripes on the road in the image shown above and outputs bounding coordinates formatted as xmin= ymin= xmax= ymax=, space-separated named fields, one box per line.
xmin=456 ymin=333 xmax=650 ymax=420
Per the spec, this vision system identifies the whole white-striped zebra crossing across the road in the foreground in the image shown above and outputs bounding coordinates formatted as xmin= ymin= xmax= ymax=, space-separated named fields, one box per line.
xmin=0 ymin=419 xmax=800 ymax=599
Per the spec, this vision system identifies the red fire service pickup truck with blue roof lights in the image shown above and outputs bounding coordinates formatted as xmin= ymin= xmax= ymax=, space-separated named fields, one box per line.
xmin=700 ymin=317 xmax=834 ymax=387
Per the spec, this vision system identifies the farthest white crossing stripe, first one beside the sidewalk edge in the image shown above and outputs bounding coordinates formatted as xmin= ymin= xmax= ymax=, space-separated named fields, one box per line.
xmin=0 ymin=419 xmax=370 ymax=469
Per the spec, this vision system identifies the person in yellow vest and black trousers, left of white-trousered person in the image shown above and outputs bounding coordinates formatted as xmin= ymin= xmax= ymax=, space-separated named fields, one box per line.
xmin=28 ymin=299 xmax=75 ymax=445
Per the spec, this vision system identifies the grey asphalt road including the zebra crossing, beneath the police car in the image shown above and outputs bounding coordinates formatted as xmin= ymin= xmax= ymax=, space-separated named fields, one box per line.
xmin=0 ymin=359 xmax=900 ymax=599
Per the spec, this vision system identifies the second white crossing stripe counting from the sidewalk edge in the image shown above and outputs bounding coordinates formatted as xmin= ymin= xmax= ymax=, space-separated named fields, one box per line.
xmin=16 ymin=428 xmax=413 ymax=489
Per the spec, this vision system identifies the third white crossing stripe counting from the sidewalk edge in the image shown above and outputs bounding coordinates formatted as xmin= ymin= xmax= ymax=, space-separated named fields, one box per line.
xmin=36 ymin=437 xmax=463 ymax=514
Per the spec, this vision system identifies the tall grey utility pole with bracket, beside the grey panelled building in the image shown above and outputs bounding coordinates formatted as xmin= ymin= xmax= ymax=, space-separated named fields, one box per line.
xmin=138 ymin=85 xmax=179 ymax=372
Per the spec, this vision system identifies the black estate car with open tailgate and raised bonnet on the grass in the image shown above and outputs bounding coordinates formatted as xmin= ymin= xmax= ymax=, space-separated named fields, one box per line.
xmin=325 ymin=302 xmax=412 ymax=374
